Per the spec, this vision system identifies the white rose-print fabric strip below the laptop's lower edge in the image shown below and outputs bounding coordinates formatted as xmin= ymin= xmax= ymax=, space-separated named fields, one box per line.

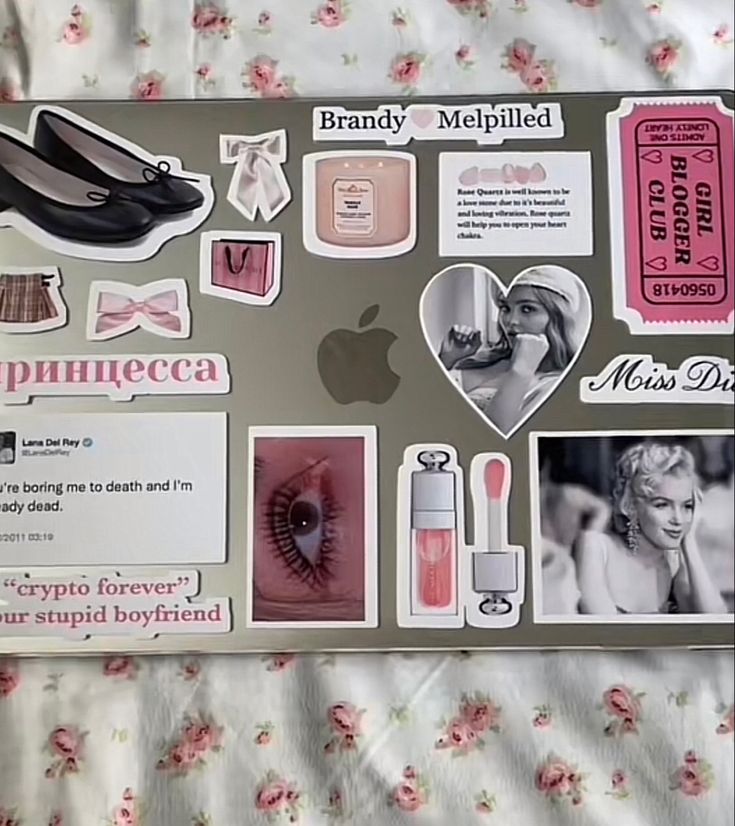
xmin=0 ymin=651 xmax=735 ymax=826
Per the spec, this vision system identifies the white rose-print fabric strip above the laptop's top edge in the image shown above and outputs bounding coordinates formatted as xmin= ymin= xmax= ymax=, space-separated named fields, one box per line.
xmin=0 ymin=0 xmax=734 ymax=102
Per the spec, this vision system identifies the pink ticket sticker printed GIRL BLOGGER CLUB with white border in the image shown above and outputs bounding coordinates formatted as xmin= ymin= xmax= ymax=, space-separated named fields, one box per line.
xmin=607 ymin=96 xmax=735 ymax=335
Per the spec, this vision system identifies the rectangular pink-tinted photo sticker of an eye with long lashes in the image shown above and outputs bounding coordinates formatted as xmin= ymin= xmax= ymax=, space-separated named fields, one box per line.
xmin=248 ymin=427 xmax=378 ymax=628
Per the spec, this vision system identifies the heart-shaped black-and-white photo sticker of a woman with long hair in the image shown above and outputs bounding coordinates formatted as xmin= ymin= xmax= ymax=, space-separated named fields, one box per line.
xmin=420 ymin=264 xmax=592 ymax=439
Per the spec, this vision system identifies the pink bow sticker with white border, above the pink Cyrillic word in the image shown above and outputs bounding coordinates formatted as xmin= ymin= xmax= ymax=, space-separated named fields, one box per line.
xmin=87 ymin=278 xmax=190 ymax=341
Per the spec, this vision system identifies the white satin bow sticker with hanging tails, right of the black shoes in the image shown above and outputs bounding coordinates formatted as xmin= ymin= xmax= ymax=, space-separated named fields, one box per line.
xmin=220 ymin=129 xmax=291 ymax=221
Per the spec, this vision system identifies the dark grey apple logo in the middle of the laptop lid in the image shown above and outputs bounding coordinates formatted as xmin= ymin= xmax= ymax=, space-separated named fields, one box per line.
xmin=317 ymin=304 xmax=401 ymax=404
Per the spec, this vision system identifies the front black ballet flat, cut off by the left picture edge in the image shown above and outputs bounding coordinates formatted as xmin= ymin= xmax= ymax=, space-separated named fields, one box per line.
xmin=0 ymin=132 xmax=156 ymax=244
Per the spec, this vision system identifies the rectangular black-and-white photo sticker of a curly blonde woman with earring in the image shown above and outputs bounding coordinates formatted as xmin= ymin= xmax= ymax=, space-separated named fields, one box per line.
xmin=531 ymin=431 xmax=735 ymax=622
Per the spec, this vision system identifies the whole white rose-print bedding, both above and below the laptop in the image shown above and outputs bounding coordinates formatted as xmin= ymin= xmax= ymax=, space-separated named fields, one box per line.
xmin=0 ymin=0 xmax=735 ymax=826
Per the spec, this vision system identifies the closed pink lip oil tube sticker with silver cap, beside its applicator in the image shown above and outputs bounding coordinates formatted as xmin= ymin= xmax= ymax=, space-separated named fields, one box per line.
xmin=397 ymin=445 xmax=464 ymax=628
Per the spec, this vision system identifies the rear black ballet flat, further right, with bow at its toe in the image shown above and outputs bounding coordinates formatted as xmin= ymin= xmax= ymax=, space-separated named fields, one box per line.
xmin=33 ymin=109 xmax=204 ymax=216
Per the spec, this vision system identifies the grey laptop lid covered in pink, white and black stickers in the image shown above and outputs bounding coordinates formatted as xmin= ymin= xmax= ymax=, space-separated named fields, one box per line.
xmin=0 ymin=93 xmax=735 ymax=654
